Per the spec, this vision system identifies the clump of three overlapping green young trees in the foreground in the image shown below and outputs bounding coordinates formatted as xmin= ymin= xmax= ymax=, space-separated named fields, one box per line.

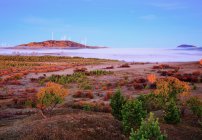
xmin=110 ymin=90 xmax=166 ymax=140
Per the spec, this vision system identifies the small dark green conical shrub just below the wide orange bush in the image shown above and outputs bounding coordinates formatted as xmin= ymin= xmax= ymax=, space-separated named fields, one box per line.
xmin=164 ymin=99 xmax=180 ymax=124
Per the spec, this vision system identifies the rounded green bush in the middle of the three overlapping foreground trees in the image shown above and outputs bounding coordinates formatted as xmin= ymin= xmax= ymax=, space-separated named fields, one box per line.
xmin=121 ymin=100 xmax=147 ymax=133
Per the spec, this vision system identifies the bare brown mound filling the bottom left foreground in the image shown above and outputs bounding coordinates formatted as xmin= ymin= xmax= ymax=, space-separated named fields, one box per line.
xmin=0 ymin=109 xmax=126 ymax=140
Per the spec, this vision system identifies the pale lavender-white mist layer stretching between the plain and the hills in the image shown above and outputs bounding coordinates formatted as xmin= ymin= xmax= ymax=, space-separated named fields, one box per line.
xmin=0 ymin=48 xmax=202 ymax=62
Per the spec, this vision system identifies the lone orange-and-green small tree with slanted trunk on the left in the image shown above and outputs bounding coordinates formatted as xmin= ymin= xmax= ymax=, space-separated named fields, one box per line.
xmin=36 ymin=82 xmax=67 ymax=118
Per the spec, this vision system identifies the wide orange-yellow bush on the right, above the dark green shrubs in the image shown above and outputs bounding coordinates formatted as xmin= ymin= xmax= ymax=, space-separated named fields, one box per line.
xmin=154 ymin=77 xmax=190 ymax=99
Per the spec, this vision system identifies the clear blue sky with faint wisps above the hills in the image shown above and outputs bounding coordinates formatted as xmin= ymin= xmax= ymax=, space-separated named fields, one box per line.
xmin=0 ymin=0 xmax=202 ymax=48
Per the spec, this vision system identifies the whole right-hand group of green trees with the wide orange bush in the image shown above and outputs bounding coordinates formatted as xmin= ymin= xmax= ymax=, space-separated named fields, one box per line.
xmin=110 ymin=77 xmax=202 ymax=140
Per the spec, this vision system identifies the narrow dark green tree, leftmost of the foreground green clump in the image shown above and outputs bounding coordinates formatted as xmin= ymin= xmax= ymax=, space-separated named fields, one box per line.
xmin=110 ymin=90 xmax=126 ymax=120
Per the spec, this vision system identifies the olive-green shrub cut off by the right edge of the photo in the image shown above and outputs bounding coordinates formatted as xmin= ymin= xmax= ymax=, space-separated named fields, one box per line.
xmin=187 ymin=97 xmax=202 ymax=119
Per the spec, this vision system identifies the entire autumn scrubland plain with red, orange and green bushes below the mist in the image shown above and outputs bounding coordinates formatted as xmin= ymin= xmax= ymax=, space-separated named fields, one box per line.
xmin=0 ymin=56 xmax=202 ymax=140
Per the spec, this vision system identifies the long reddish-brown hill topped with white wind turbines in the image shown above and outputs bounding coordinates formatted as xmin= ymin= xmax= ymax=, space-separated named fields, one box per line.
xmin=15 ymin=40 xmax=106 ymax=49
